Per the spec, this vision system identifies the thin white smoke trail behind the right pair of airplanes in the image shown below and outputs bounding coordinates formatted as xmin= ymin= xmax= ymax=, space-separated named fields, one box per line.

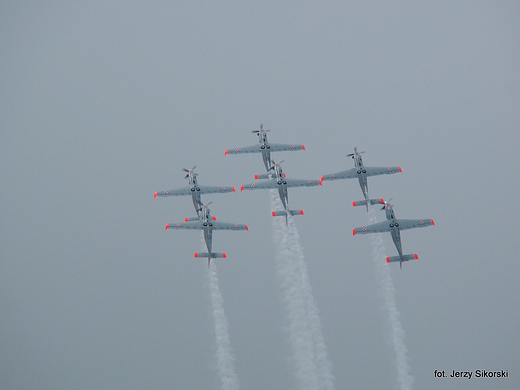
xmin=368 ymin=208 xmax=414 ymax=390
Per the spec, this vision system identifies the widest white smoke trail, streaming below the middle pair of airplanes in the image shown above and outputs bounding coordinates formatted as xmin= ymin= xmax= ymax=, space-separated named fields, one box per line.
xmin=271 ymin=190 xmax=334 ymax=390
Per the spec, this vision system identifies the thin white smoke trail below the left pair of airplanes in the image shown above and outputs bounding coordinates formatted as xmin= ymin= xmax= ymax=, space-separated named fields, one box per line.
xmin=202 ymin=236 xmax=239 ymax=390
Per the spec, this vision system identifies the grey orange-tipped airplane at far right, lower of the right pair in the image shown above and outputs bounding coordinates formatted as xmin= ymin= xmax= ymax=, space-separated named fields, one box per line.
xmin=352 ymin=199 xmax=435 ymax=269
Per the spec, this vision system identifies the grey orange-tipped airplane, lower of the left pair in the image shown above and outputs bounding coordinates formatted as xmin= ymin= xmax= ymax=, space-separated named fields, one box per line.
xmin=165 ymin=202 xmax=249 ymax=267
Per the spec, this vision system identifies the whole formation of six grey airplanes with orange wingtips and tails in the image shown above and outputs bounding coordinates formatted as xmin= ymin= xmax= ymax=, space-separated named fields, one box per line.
xmin=154 ymin=124 xmax=435 ymax=269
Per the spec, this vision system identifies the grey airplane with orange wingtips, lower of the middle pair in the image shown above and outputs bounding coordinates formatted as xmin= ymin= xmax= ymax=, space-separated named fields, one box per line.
xmin=240 ymin=161 xmax=321 ymax=222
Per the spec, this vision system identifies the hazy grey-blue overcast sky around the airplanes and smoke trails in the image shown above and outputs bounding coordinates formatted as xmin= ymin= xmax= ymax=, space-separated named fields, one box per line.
xmin=0 ymin=1 xmax=520 ymax=390
